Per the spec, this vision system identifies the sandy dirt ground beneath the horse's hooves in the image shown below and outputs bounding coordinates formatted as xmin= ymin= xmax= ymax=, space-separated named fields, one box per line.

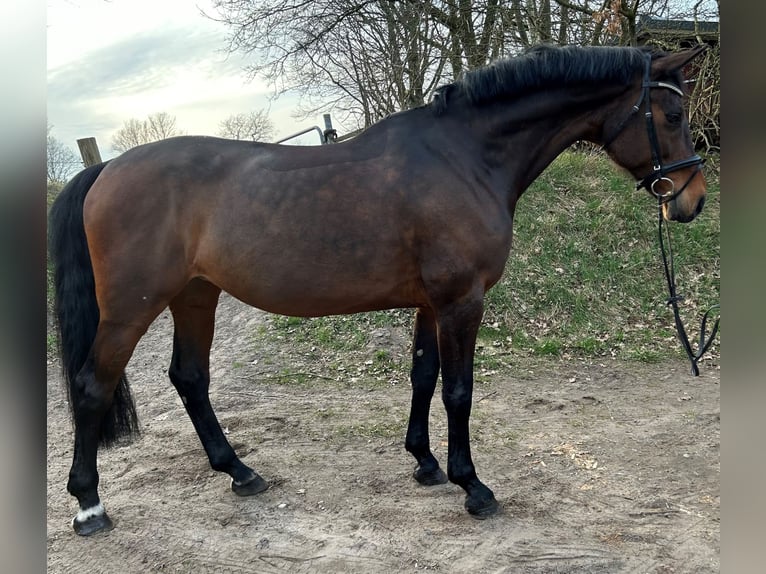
xmin=47 ymin=297 xmax=720 ymax=574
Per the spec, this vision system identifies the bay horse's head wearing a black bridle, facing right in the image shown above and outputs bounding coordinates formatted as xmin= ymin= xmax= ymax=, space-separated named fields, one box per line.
xmin=604 ymin=46 xmax=706 ymax=223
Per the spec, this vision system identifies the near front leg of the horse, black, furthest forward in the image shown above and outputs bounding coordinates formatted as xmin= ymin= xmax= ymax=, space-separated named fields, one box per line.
xmin=437 ymin=295 xmax=499 ymax=518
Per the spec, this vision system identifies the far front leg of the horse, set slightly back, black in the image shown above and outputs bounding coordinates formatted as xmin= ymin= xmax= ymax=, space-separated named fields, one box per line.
xmin=404 ymin=308 xmax=447 ymax=486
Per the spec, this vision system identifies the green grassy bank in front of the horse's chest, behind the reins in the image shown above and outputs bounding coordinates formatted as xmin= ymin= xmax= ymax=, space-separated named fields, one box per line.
xmin=482 ymin=152 xmax=720 ymax=362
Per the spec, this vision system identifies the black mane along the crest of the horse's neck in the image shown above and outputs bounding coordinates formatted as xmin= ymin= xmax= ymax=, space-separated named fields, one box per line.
xmin=433 ymin=45 xmax=664 ymax=113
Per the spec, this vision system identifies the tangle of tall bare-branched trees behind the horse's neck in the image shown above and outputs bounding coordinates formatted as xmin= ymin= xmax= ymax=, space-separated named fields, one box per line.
xmin=208 ymin=0 xmax=717 ymax=127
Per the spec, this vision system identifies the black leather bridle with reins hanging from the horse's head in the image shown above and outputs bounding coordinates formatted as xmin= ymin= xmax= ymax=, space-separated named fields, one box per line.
xmin=602 ymin=53 xmax=721 ymax=377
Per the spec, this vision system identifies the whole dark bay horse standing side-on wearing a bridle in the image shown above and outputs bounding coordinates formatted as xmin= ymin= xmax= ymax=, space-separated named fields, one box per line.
xmin=49 ymin=46 xmax=706 ymax=535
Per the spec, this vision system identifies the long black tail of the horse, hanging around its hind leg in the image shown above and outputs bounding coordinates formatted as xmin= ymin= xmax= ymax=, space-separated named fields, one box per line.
xmin=48 ymin=162 xmax=139 ymax=446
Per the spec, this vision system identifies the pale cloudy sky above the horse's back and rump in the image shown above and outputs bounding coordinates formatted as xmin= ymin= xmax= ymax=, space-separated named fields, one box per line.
xmin=47 ymin=0 xmax=332 ymax=159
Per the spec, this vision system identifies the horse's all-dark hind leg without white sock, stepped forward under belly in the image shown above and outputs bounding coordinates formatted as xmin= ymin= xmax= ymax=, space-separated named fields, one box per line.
xmin=168 ymin=279 xmax=267 ymax=496
